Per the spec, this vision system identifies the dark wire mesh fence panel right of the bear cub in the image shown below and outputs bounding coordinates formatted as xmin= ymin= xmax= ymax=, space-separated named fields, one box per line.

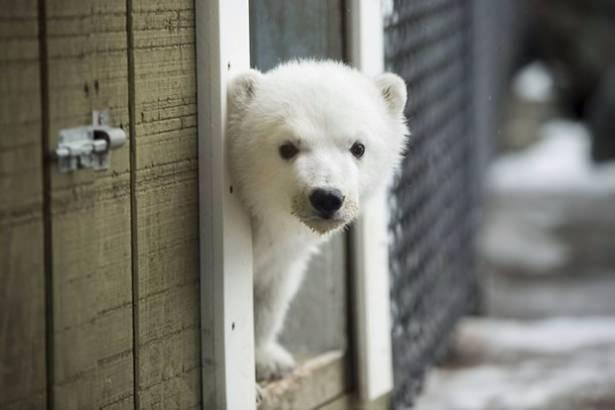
xmin=385 ymin=0 xmax=510 ymax=409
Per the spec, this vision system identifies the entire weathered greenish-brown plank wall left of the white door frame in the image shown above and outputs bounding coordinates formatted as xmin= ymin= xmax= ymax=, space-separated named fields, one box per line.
xmin=0 ymin=0 xmax=201 ymax=410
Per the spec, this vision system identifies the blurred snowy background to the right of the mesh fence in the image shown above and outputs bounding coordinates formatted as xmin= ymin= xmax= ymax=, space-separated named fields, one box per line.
xmin=406 ymin=0 xmax=615 ymax=410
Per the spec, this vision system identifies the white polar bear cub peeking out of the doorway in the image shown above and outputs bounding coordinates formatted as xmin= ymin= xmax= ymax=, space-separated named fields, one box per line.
xmin=227 ymin=60 xmax=408 ymax=380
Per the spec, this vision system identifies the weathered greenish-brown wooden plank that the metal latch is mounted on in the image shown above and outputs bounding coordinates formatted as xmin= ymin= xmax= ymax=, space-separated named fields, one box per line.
xmin=45 ymin=0 xmax=134 ymax=410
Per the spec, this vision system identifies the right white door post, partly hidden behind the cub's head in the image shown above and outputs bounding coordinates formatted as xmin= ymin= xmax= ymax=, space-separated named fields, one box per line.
xmin=348 ymin=0 xmax=393 ymax=401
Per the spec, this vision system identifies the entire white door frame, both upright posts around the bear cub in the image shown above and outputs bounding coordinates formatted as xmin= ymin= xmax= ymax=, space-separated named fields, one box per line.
xmin=195 ymin=0 xmax=393 ymax=410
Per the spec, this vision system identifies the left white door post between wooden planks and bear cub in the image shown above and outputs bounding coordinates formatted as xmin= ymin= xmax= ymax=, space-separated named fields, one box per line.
xmin=195 ymin=0 xmax=256 ymax=410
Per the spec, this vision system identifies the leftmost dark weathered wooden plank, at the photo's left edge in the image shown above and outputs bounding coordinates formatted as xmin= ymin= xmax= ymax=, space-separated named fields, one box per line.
xmin=0 ymin=0 xmax=46 ymax=409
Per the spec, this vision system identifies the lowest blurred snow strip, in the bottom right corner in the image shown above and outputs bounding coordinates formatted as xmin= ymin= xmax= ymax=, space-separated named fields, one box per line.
xmin=416 ymin=351 xmax=615 ymax=410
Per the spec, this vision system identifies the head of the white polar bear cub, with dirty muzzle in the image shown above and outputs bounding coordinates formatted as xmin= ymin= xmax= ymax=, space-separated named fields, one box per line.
xmin=227 ymin=61 xmax=408 ymax=233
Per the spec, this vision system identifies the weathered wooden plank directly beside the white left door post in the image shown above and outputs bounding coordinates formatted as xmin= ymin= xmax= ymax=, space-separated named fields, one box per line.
xmin=131 ymin=0 xmax=201 ymax=409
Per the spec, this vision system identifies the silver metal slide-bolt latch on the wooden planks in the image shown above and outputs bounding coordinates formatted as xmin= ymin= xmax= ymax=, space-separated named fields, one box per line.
xmin=56 ymin=112 xmax=126 ymax=172
